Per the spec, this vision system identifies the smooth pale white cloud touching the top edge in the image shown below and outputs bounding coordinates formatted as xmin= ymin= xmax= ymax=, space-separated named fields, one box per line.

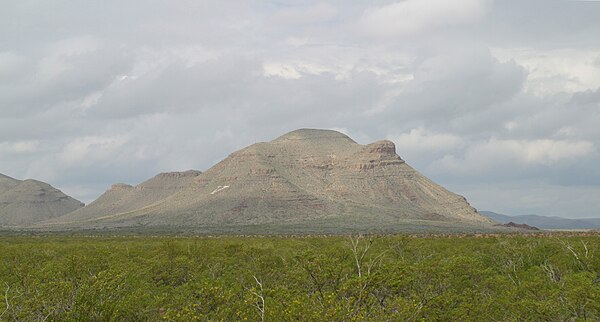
xmin=359 ymin=0 xmax=490 ymax=37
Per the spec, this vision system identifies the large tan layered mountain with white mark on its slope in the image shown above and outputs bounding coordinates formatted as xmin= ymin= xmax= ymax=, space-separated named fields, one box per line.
xmin=43 ymin=129 xmax=494 ymax=233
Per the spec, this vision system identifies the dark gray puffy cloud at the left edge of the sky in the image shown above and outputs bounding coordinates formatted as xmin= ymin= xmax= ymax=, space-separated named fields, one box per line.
xmin=0 ymin=39 xmax=132 ymax=117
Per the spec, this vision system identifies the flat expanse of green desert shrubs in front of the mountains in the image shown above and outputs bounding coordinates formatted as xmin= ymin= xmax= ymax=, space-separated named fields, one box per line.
xmin=0 ymin=234 xmax=600 ymax=321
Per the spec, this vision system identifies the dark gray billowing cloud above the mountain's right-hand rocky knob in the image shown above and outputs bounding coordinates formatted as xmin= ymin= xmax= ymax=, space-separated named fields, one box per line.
xmin=382 ymin=49 xmax=527 ymax=132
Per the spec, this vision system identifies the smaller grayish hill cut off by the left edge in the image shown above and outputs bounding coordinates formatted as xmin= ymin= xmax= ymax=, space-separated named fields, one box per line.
xmin=0 ymin=174 xmax=84 ymax=227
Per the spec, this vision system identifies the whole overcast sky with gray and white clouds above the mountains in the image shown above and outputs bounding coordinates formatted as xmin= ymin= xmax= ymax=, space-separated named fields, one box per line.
xmin=0 ymin=0 xmax=600 ymax=217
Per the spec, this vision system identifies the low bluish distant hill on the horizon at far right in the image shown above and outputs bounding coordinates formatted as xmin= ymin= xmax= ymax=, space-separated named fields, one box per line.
xmin=479 ymin=211 xmax=600 ymax=229
